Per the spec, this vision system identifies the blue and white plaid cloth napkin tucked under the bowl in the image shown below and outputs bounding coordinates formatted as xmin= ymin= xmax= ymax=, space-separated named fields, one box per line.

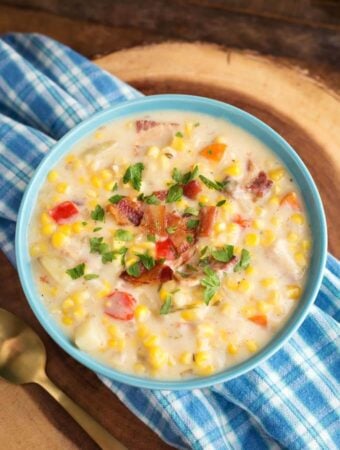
xmin=0 ymin=34 xmax=340 ymax=450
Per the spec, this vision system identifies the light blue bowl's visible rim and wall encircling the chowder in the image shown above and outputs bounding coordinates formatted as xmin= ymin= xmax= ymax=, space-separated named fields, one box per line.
xmin=15 ymin=95 xmax=327 ymax=389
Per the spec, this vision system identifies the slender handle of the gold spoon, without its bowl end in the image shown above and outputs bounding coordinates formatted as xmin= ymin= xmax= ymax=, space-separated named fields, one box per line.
xmin=36 ymin=376 xmax=127 ymax=450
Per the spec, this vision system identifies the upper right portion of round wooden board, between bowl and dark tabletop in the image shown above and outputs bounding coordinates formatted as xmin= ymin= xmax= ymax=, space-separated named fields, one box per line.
xmin=96 ymin=43 xmax=340 ymax=257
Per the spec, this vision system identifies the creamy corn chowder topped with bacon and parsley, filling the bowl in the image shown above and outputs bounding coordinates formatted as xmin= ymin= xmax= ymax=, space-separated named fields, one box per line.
xmin=30 ymin=111 xmax=311 ymax=379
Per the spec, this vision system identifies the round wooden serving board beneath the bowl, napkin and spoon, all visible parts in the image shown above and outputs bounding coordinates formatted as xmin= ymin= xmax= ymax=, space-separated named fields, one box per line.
xmin=0 ymin=43 xmax=340 ymax=450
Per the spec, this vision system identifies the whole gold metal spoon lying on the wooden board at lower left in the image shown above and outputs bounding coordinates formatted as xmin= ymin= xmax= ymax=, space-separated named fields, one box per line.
xmin=0 ymin=308 xmax=127 ymax=450
